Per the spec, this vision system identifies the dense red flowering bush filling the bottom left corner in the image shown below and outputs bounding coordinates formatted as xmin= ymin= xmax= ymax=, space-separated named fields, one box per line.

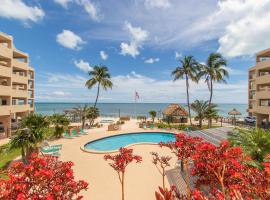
xmin=0 ymin=154 xmax=88 ymax=200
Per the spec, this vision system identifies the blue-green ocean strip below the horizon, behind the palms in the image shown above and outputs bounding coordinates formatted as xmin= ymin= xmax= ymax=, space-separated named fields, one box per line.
xmin=35 ymin=103 xmax=247 ymax=117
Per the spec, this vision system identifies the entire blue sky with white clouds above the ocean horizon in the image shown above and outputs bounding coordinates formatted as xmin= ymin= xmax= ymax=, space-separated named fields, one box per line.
xmin=0 ymin=0 xmax=270 ymax=103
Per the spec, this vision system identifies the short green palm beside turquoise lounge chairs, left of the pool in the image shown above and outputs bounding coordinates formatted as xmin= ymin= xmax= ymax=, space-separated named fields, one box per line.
xmin=49 ymin=114 xmax=70 ymax=138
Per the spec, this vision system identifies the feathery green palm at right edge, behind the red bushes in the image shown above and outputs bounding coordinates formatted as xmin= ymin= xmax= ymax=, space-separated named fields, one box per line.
xmin=229 ymin=129 xmax=270 ymax=166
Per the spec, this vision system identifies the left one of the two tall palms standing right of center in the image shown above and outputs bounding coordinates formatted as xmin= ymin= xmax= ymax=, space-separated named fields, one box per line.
xmin=172 ymin=56 xmax=199 ymax=125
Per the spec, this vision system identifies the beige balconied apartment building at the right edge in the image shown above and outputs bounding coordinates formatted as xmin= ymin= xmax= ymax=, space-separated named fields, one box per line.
xmin=248 ymin=48 xmax=270 ymax=126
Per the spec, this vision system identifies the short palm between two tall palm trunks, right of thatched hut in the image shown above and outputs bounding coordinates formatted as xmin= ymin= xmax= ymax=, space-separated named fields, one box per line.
xmin=191 ymin=100 xmax=209 ymax=128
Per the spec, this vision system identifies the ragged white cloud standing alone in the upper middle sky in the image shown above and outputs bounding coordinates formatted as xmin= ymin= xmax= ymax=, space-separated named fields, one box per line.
xmin=120 ymin=22 xmax=149 ymax=58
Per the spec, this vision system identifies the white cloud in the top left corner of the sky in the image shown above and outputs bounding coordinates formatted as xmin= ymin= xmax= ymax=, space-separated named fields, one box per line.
xmin=0 ymin=0 xmax=45 ymax=22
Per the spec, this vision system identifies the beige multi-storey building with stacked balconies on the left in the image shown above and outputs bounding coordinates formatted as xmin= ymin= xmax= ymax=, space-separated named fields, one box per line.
xmin=0 ymin=32 xmax=35 ymax=139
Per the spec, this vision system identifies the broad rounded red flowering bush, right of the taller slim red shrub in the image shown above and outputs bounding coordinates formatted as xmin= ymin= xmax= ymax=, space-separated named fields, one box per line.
xmin=192 ymin=141 xmax=245 ymax=196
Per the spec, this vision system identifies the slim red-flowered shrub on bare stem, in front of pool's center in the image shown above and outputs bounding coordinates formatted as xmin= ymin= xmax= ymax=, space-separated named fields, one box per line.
xmin=104 ymin=147 xmax=142 ymax=200
